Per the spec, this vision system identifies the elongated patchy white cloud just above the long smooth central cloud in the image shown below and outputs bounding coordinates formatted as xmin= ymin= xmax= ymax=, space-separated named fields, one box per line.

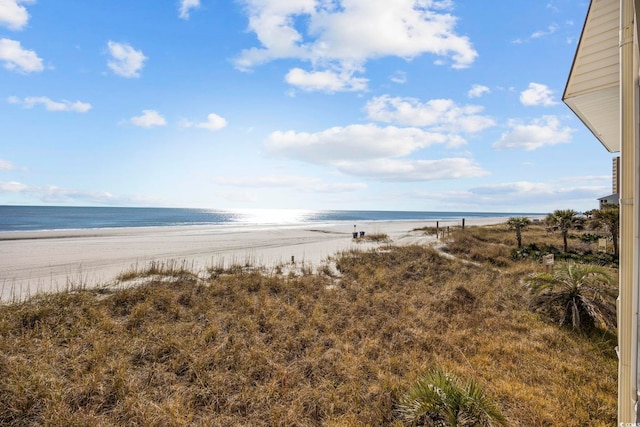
xmin=365 ymin=95 xmax=495 ymax=133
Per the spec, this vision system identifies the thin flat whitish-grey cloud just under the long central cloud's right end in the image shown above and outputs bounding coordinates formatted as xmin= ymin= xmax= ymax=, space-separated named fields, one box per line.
xmin=338 ymin=158 xmax=489 ymax=182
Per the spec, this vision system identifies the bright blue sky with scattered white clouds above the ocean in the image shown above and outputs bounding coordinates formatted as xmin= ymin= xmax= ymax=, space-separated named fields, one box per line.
xmin=0 ymin=0 xmax=613 ymax=213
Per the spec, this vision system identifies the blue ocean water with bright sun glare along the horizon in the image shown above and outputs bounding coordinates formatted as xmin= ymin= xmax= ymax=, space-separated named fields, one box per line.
xmin=0 ymin=206 xmax=540 ymax=232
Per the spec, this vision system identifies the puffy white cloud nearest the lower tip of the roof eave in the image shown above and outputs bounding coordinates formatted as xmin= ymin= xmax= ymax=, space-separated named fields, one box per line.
xmin=493 ymin=116 xmax=574 ymax=151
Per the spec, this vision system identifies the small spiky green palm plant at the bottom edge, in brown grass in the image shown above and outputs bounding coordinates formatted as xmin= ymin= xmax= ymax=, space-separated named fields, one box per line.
xmin=398 ymin=368 xmax=507 ymax=427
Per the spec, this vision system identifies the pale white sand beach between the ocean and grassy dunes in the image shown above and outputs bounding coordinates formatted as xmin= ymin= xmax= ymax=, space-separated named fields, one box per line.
xmin=0 ymin=217 xmax=507 ymax=302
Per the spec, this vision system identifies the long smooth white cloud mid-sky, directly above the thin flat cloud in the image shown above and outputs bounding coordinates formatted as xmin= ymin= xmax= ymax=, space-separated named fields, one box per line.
xmin=266 ymin=124 xmax=460 ymax=165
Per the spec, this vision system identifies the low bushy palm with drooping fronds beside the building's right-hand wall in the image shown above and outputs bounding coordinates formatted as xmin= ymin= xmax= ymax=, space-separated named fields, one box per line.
xmin=525 ymin=262 xmax=618 ymax=330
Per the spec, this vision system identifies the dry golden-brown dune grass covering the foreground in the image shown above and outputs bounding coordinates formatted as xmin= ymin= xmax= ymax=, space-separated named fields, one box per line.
xmin=0 ymin=227 xmax=617 ymax=426
